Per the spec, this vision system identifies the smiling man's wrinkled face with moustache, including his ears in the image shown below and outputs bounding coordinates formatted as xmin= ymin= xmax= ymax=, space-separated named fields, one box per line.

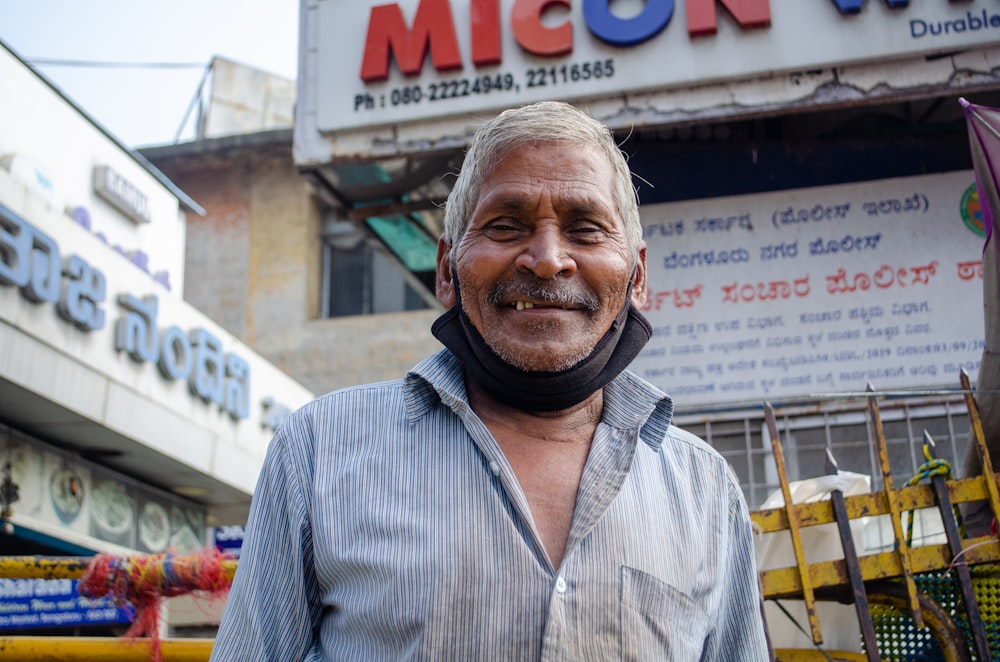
xmin=437 ymin=143 xmax=646 ymax=372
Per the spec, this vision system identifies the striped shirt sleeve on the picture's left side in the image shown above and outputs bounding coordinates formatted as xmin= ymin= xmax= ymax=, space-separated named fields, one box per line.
xmin=211 ymin=421 xmax=321 ymax=662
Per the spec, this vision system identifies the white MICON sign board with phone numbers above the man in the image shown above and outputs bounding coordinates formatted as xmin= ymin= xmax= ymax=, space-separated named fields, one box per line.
xmin=312 ymin=0 xmax=1000 ymax=134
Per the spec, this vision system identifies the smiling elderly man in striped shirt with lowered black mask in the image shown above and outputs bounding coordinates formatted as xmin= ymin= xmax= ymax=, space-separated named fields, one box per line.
xmin=212 ymin=102 xmax=768 ymax=662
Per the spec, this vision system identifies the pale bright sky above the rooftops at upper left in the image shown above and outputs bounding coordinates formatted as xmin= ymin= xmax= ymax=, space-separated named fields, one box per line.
xmin=0 ymin=0 xmax=299 ymax=147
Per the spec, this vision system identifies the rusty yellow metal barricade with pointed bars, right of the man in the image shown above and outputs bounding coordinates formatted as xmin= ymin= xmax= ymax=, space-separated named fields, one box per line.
xmin=750 ymin=371 xmax=1000 ymax=662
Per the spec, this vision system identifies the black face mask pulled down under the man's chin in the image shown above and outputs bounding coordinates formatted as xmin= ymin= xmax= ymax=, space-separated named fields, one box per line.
xmin=431 ymin=271 xmax=652 ymax=411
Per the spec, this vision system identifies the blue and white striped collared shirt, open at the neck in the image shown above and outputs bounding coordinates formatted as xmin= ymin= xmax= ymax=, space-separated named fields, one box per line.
xmin=212 ymin=350 xmax=768 ymax=662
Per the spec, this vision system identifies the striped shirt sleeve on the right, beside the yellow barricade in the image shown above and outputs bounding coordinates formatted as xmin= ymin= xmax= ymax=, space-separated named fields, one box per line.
xmin=702 ymin=467 xmax=771 ymax=662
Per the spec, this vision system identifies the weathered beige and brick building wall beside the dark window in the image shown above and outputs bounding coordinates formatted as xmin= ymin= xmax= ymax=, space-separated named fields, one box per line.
xmin=144 ymin=137 xmax=441 ymax=393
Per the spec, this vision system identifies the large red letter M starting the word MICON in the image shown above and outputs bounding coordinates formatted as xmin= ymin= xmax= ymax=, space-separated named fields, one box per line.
xmin=361 ymin=0 xmax=462 ymax=83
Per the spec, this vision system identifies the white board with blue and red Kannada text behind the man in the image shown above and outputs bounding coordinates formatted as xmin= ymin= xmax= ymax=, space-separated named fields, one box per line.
xmin=631 ymin=171 xmax=984 ymax=406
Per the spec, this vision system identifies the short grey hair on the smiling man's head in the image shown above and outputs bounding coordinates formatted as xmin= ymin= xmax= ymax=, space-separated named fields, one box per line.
xmin=444 ymin=101 xmax=642 ymax=260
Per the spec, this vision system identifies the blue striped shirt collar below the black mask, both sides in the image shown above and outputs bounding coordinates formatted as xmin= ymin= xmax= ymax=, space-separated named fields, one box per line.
xmin=404 ymin=349 xmax=674 ymax=449
